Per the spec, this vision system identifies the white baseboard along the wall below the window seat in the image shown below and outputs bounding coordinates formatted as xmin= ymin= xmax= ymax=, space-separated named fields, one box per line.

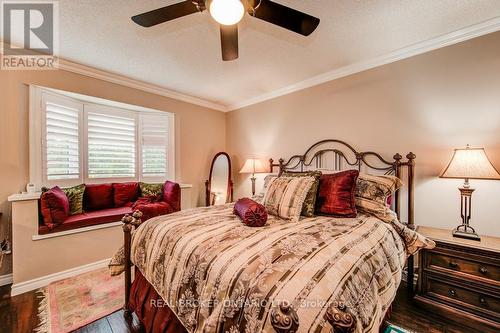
xmin=10 ymin=259 xmax=110 ymax=296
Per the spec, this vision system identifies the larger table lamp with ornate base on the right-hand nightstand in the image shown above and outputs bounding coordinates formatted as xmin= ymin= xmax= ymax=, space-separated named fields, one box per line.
xmin=439 ymin=145 xmax=500 ymax=241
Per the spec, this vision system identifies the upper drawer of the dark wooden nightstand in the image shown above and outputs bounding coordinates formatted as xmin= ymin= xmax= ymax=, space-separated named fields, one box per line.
xmin=425 ymin=251 xmax=500 ymax=285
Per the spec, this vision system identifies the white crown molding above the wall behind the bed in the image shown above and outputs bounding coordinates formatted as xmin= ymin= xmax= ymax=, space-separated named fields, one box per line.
xmin=227 ymin=17 xmax=500 ymax=111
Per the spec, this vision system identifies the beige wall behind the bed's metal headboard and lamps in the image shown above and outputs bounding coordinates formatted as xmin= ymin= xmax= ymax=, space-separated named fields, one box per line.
xmin=226 ymin=32 xmax=500 ymax=236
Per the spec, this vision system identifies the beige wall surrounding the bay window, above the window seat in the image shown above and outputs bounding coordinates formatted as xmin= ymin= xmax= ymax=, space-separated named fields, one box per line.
xmin=0 ymin=70 xmax=226 ymax=275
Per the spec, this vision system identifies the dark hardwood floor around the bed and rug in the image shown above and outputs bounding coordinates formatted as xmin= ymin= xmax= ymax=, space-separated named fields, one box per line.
xmin=0 ymin=286 xmax=480 ymax=333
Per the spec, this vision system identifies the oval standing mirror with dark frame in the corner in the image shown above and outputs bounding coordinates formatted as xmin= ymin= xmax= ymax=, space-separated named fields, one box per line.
xmin=205 ymin=152 xmax=233 ymax=206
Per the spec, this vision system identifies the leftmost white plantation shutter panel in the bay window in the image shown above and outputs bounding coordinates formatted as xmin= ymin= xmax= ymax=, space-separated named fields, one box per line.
xmin=42 ymin=94 xmax=83 ymax=180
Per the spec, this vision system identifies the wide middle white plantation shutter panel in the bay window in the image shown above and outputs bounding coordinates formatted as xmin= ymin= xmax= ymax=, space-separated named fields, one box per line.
xmin=87 ymin=107 xmax=136 ymax=179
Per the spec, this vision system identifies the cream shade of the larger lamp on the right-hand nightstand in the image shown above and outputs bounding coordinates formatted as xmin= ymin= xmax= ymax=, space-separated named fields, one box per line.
xmin=440 ymin=146 xmax=500 ymax=179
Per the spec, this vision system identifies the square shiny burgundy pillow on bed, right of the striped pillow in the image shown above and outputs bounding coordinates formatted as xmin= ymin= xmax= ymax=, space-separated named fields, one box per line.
xmin=316 ymin=170 xmax=359 ymax=217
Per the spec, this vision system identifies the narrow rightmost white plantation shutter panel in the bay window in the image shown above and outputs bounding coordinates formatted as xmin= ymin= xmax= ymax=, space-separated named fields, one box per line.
xmin=140 ymin=114 xmax=169 ymax=179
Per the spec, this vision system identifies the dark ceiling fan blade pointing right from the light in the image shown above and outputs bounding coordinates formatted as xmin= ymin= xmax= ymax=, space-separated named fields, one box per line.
xmin=249 ymin=0 xmax=320 ymax=36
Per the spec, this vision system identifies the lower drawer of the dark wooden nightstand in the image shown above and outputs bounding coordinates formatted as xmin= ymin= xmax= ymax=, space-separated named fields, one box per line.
xmin=424 ymin=275 xmax=500 ymax=321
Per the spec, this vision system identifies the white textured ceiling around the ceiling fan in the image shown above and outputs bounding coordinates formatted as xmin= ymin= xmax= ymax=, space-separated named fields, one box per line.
xmin=59 ymin=0 xmax=500 ymax=108
